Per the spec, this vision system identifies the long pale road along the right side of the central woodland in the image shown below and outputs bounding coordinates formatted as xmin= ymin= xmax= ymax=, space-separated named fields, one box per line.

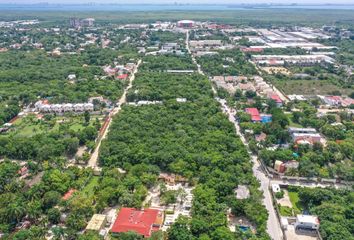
xmin=186 ymin=31 xmax=283 ymax=240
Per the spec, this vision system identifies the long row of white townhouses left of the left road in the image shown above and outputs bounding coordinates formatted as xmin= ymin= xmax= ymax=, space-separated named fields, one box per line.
xmin=34 ymin=100 xmax=94 ymax=113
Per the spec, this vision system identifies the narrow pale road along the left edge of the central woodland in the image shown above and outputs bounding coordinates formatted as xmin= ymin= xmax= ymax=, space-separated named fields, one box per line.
xmin=87 ymin=60 xmax=141 ymax=168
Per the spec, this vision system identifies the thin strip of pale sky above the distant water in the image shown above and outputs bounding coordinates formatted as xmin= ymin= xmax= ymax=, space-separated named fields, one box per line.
xmin=0 ymin=0 xmax=354 ymax=4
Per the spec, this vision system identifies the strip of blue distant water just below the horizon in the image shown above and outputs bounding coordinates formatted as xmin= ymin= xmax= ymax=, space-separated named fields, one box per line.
xmin=0 ymin=4 xmax=354 ymax=12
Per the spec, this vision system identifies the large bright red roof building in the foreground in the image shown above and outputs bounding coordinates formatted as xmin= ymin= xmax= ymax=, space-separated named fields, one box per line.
xmin=111 ymin=208 xmax=163 ymax=237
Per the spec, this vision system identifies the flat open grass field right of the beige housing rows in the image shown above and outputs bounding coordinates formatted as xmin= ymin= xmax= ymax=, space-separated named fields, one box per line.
xmin=273 ymin=80 xmax=353 ymax=95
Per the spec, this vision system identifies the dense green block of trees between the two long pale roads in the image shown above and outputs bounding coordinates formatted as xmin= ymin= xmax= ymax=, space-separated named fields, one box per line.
xmin=99 ymin=53 xmax=269 ymax=240
